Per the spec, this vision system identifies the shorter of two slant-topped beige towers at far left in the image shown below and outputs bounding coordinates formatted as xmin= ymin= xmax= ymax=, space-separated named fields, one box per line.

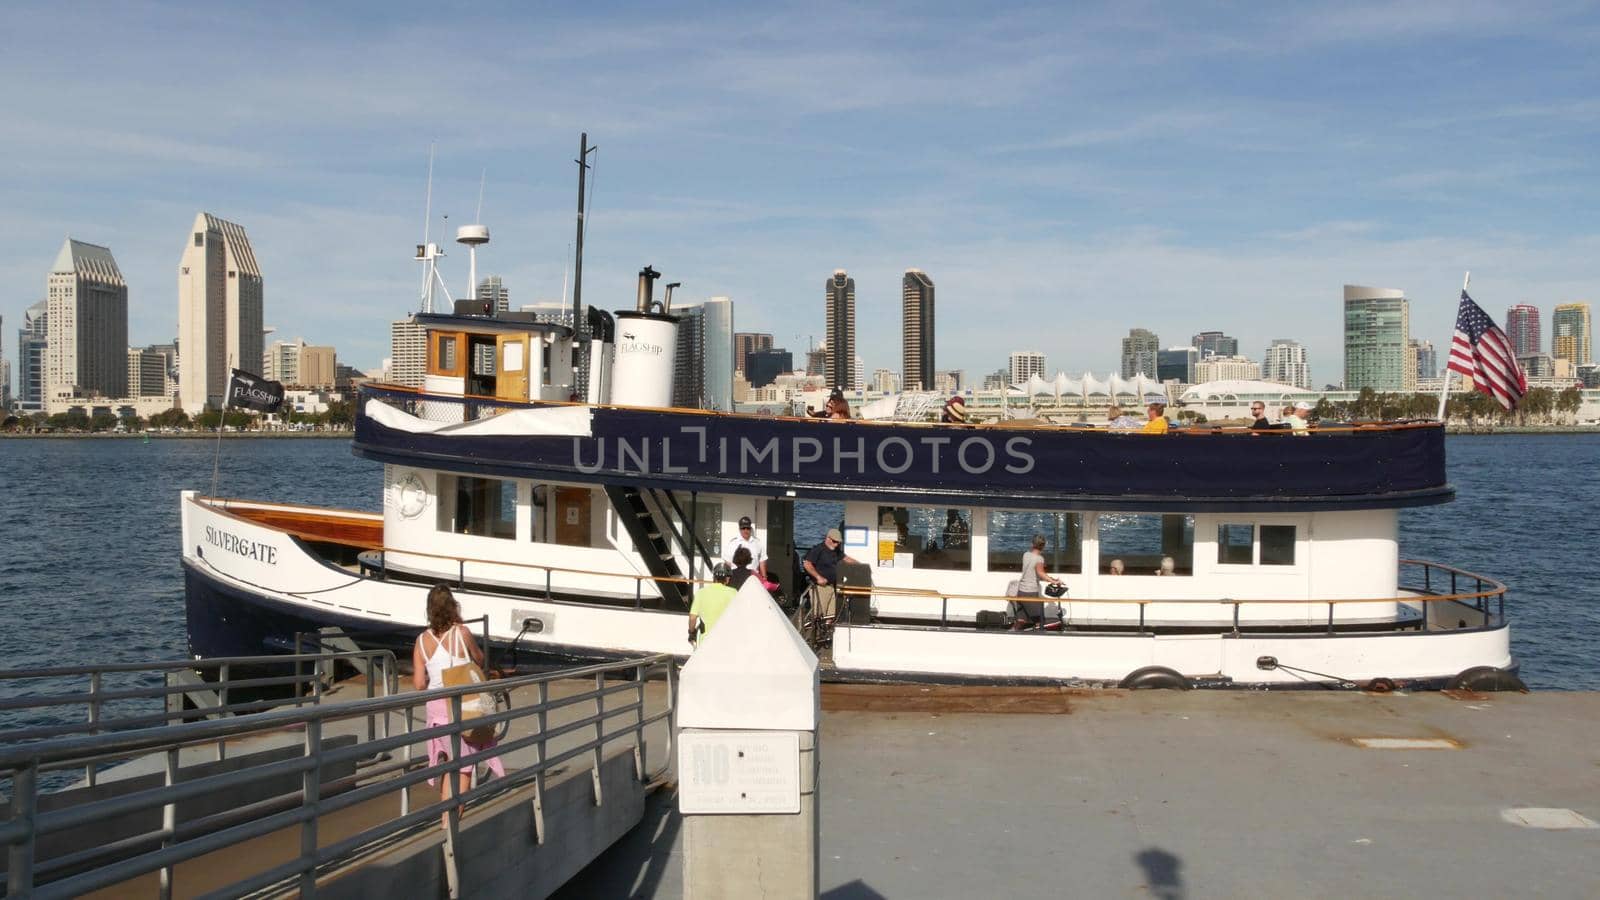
xmin=45 ymin=237 xmax=128 ymax=407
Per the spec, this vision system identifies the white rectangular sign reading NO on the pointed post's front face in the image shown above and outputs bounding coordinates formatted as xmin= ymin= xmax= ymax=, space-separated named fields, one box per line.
xmin=678 ymin=730 xmax=800 ymax=815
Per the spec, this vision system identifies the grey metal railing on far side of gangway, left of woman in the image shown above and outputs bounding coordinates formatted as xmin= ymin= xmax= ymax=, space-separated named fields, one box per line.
xmin=0 ymin=650 xmax=398 ymax=786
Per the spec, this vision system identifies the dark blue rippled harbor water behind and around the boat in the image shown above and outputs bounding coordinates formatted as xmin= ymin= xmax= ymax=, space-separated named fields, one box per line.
xmin=0 ymin=434 xmax=1600 ymax=688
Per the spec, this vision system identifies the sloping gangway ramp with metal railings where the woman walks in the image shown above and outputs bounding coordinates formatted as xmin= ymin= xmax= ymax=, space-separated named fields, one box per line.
xmin=0 ymin=652 xmax=675 ymax=897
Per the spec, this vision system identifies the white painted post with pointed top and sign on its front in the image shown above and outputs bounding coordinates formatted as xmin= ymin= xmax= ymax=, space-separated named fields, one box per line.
xmin=677 ymin=578 xmax=822 ymax=900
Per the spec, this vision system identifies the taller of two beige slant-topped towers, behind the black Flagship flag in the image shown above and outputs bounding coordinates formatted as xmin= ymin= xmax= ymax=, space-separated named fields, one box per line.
xmin=178 ymin=213 xmax=264 ymax=415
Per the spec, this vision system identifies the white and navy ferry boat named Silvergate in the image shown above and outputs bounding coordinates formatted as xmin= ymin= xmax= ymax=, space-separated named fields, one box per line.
xmin=181 ymin=267 xmax=1520 ymax=690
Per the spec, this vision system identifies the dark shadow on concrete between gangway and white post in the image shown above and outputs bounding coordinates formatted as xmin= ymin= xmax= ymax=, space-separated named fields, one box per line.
xmin=550 ymin=790 xmax=683 ymax=900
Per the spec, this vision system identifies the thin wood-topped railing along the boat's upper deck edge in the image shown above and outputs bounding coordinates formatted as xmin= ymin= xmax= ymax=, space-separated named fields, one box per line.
xmin=362 ymin=383 xmax=1443 ymax=437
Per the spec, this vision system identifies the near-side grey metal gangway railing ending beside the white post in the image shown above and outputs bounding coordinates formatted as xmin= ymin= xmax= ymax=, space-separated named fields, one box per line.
xmin=0 ymin=653 xmax=677 ymax=898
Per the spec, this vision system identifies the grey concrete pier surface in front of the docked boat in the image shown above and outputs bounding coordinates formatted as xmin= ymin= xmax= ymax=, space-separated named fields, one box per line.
xmin=557 ymin=687 xmax=1600 ymax=900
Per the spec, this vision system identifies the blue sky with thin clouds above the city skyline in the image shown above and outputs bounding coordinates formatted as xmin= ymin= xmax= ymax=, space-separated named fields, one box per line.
xmin=0 ymin=2 xmax=1600 ymax=383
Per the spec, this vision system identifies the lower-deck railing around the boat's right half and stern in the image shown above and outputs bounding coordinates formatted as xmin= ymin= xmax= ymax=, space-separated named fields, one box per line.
xmin=838 ymin=559 xmax=1506 ymax=634
